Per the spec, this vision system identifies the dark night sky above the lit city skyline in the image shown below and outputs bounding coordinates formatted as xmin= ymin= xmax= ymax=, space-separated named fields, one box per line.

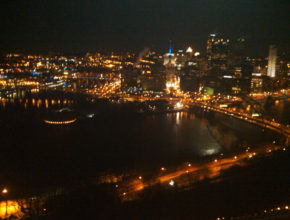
xmin=0 ymin=0 xmax=290 ymax=56
